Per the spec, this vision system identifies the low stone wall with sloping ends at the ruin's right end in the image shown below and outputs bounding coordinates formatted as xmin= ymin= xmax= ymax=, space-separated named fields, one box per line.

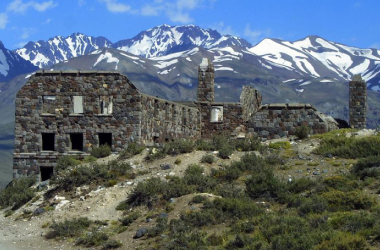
xmin=248 ymin=103 xmax=337 ymax=139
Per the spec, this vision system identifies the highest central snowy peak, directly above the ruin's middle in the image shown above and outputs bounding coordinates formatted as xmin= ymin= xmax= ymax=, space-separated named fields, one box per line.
xmin=112 ymin=25 xmax=252 ymax=58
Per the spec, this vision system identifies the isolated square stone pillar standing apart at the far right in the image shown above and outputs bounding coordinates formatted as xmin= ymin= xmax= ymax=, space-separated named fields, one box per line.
xmin=349 ymin=75 xmax=367 ymax=129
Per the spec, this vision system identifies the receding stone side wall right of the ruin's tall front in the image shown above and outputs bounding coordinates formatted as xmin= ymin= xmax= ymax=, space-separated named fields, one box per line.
xmin=141 ymin=94 xmax=201 ymax=146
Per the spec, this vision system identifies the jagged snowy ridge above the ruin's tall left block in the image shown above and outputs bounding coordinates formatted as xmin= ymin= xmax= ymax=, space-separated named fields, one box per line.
xmin=15 ymin=33 xmax=112 ymax=68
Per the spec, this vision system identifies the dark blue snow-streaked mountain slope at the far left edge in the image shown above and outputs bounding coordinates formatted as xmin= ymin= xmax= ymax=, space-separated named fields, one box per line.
xmin=0 ymin=41 xmax=37 ymax=82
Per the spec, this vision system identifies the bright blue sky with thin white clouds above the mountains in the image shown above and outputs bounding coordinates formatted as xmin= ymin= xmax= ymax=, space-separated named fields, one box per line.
xmin=0 ymin=0 xmax=380 ymax=49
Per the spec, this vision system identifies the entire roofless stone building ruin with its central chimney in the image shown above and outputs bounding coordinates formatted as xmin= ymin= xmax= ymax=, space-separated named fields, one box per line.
xmin=13 ymin=59 xmax=346 ymax=180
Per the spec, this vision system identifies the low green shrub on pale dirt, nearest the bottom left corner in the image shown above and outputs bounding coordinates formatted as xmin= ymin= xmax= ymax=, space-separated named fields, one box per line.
xmin=45 ymin=217 xmax=92 ymax=239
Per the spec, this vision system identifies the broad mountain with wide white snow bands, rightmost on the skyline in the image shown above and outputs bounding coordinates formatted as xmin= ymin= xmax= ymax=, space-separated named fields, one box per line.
xmin=249 ymin=36 xmax=380 ymax=90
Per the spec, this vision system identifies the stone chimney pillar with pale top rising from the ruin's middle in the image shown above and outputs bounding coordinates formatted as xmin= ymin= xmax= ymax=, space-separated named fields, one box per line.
xmin=197 ymin=58 xmax=214 ymax=102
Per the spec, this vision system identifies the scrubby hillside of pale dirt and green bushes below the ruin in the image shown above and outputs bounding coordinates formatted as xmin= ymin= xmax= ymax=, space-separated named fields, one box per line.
xmin=0 ymin=130 xmax=380 ymax=250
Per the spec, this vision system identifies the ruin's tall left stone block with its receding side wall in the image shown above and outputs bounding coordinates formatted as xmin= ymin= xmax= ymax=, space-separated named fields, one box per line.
xmin=13 ymin=72 xmax=201 ymax=177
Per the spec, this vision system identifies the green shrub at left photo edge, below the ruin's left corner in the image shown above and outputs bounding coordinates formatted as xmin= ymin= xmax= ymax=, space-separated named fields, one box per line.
xmin=0 ymin=176 xmax=36 ymax=210
